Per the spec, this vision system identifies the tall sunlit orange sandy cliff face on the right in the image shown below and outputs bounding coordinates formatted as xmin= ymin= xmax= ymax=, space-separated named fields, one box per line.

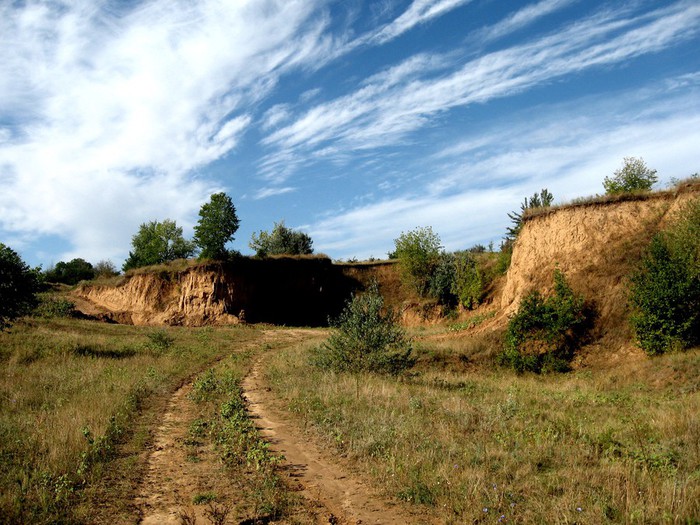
xmin=500 ymin=186 xmax=700 ymax=337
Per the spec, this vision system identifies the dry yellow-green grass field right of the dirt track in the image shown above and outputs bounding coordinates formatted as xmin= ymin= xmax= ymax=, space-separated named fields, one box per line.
xmin=269 ymin=334 xmax=700 ymax=523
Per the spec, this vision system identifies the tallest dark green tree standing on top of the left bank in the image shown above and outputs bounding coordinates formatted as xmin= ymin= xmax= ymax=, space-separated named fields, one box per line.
xmin=194 ymin=192 xmax=239 ymax=260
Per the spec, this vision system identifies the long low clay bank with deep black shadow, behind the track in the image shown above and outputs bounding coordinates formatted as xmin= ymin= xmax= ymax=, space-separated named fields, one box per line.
xmin=75 ymin=257 xmax=393 ymax=326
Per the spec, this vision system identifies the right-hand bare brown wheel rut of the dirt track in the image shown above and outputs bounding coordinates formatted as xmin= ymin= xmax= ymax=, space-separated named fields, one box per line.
xmin=243 ymin=346 xmax=432 ymax=525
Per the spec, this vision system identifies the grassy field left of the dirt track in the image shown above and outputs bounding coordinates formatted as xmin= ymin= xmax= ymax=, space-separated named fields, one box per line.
xmin=0 ymin=318 xmax=261 ymax=523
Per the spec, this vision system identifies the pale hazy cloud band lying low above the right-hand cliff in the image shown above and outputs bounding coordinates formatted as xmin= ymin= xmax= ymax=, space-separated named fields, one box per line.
xmin=309 ymin=86 xmax=700 ymax=258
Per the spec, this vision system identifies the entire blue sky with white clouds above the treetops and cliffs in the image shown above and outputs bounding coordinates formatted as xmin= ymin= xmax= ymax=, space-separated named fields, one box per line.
xmin=0 ymin=0 xmax=700 ymax=267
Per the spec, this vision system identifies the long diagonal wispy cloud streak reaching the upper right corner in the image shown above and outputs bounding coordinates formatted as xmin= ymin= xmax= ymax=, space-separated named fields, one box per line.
xmin=264 ymin=2 xmax=700 ymax=174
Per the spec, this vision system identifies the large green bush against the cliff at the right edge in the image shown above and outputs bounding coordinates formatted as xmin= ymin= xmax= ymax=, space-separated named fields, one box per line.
xmin=630 ymin=199 xmax=700 ymax=354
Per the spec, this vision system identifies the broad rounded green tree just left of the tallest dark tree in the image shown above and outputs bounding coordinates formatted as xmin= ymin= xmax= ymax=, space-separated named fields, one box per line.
xmin=122 ymin=219 xmax=195 ymax=271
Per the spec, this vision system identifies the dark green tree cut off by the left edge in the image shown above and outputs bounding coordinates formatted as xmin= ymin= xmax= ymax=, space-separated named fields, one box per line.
xmin=0 ymin=243 xmax=40 ymax=330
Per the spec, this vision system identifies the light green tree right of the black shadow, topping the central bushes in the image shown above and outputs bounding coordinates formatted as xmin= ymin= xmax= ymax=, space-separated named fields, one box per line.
xmin=394 ymin=226 xmax=442 ymax=295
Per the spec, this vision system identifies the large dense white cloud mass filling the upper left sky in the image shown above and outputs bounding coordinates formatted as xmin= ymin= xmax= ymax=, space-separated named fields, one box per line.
xmin=0 ymin=0 xmax=327 ymax=258
